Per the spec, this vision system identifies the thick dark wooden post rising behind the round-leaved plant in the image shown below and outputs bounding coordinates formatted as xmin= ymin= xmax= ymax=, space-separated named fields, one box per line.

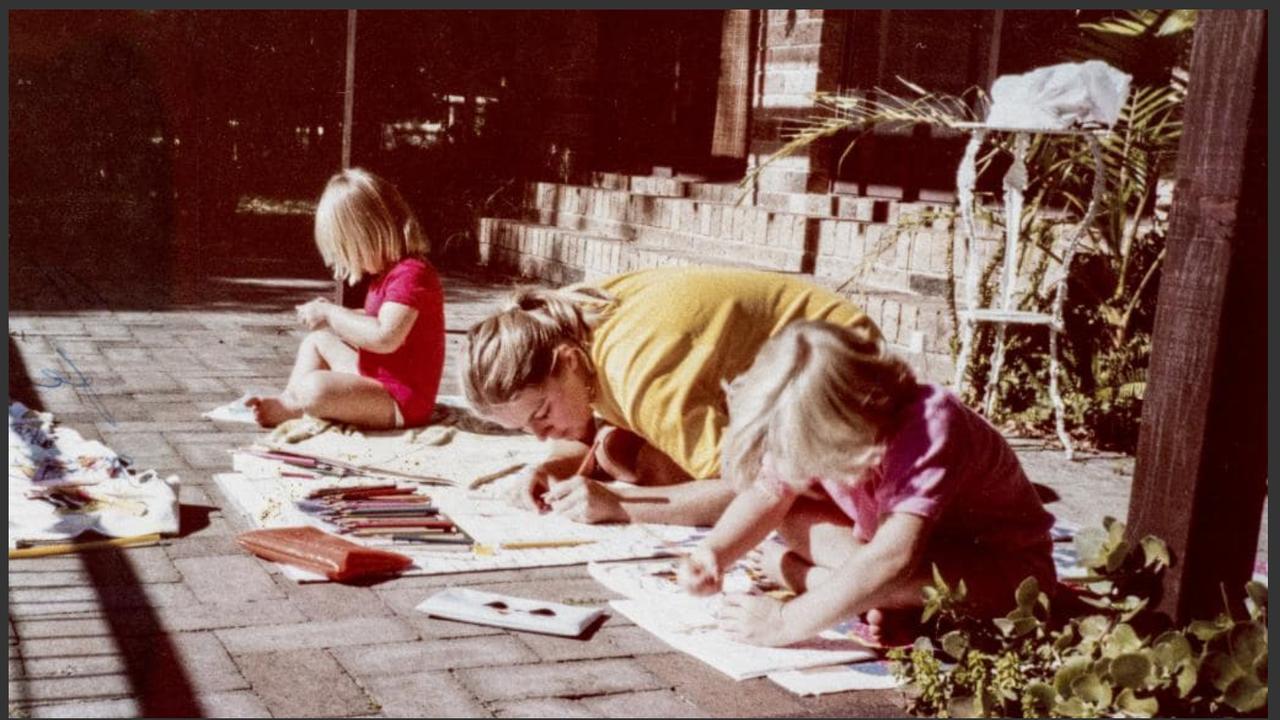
xmin=1128 ymin=10 xmax=1267 ymax=623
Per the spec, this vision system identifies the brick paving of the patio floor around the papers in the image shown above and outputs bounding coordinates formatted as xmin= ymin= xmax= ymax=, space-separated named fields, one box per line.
xmin=8 ymin=237 xmax=1259 ymax=717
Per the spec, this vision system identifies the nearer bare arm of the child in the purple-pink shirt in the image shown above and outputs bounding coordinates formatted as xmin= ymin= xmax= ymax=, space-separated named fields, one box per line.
xmin=728 ymin=512 xmax=928 ymax=646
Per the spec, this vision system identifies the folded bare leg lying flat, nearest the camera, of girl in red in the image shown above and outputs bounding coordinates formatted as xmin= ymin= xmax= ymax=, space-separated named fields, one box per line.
xmin=284 ymin=370 xmax=396 ymax=430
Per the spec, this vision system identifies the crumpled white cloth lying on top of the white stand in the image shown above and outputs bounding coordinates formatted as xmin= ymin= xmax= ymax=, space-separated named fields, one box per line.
xmin=987 ymin=60 xmax=1133 ymax=129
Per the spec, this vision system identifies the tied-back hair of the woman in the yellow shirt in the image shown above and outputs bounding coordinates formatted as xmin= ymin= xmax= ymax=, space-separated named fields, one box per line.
xmin=461 ymin=286 xmax=613 ymax=413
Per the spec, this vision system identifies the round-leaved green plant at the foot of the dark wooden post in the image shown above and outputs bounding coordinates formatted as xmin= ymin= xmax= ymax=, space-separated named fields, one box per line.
xmin=890 ymin=518 xmax=1267 ymax=717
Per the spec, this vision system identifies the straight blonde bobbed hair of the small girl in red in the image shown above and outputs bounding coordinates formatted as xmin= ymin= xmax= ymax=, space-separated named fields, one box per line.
xmin=315 ymin=168 xmax=431 ymax=284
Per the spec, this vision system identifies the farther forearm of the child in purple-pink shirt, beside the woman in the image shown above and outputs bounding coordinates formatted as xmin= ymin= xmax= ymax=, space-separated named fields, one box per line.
xmin=678 ymin=483 xmax=796 ymax=594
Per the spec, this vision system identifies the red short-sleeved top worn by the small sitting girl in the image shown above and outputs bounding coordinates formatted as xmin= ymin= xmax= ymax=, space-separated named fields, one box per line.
xmin=358 ymin=258 xmax=444 ymax=427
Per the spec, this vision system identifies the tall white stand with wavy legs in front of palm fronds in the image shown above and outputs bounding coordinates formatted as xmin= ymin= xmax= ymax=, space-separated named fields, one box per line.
xmin=952 ymin=123 xmax=1108 ymax=460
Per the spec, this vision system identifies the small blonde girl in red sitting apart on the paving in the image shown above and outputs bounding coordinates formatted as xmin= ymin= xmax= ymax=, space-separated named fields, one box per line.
xmin=248 ymin=168 xmax=444 ymax=429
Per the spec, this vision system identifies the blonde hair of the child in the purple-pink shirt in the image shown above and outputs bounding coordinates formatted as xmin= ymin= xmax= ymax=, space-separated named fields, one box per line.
xmin=721 ymin=320 xmax=916 ymax=491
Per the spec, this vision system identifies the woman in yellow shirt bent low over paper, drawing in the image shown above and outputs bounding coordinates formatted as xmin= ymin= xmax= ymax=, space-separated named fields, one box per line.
xmin=462 ymin=268 xmax=879 ymax=525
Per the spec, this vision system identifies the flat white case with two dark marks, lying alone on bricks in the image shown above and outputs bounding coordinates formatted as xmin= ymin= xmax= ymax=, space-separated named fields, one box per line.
xmin=415 ymin=588 xmax=604 ymax=638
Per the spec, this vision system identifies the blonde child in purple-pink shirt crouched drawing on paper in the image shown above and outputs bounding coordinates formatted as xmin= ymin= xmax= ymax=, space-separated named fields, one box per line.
xmin=678 ymin=322 xmax=1055 ymax=646
